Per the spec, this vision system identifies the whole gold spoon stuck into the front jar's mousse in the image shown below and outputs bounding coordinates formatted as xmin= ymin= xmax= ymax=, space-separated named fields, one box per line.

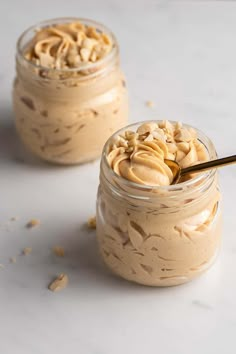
xmin=165 ymin=155 xmax=236 ymax=184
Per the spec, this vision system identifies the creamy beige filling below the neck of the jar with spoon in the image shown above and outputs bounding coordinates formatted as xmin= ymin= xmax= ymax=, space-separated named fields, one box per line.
xmin=97 ymin=194 xmax=221 ymax=286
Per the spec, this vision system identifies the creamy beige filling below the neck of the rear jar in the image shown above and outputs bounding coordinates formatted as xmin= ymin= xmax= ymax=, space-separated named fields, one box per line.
xmin=14 ymin=71 xmax=128 ymax=164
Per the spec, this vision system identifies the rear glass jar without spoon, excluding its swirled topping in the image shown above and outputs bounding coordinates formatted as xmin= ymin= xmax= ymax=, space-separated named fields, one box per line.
xmin=13 ymin=18 xmax=128 ymax=164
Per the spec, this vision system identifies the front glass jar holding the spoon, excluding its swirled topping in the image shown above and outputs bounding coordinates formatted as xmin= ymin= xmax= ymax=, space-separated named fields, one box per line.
xmin=97 ymin=122 xmax=222 ymax=286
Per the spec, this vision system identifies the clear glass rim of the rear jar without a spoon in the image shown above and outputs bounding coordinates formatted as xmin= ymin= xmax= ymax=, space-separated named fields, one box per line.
xmin=16 ymin=17 xmax=119 ymax=74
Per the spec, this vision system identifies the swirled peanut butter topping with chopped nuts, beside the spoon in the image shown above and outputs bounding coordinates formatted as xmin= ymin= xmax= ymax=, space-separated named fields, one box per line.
xmin=107 ymin=121 xmax=208 ymax=186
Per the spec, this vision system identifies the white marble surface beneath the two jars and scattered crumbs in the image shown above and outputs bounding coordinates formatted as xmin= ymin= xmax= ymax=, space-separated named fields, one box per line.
xmin=0 ymin=0 xmax=236 ymax=354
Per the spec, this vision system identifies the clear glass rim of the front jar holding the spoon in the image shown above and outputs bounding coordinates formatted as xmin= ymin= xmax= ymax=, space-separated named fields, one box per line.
xmin=102 ymin=120 xmax=217 ymax=192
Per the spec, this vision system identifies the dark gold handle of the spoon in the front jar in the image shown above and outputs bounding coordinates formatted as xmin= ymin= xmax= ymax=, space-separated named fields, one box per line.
xmin=181 ymin=155 xmax=236 ymax=176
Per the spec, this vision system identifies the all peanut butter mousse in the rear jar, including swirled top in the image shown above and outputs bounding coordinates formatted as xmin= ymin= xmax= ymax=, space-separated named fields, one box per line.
xmin=13 ymin=19 xmax=128 ymax=164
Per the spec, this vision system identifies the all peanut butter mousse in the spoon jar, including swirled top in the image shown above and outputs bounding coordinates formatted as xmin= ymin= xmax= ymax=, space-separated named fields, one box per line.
xmin=96 ymin=121 xmax=221 ymax=286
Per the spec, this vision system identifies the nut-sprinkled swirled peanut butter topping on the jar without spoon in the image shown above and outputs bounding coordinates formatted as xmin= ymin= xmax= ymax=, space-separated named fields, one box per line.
xmin=24 ymin=22 xmax=113 ymax=69
